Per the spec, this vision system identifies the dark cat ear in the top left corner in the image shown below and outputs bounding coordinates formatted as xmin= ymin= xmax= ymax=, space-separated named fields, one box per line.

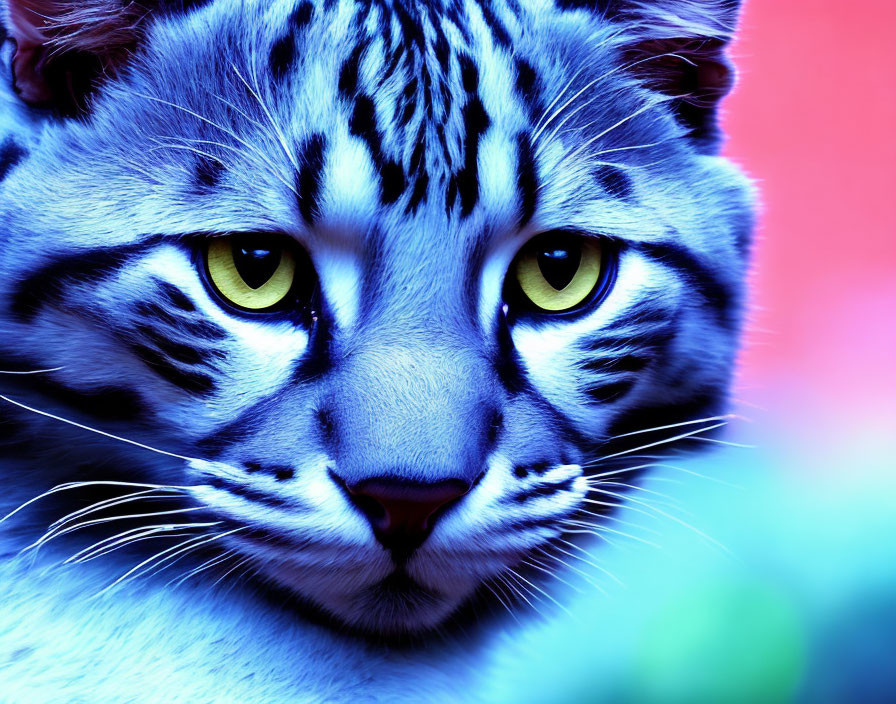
xmin=0 ymin=0 xmax=146 ymax=115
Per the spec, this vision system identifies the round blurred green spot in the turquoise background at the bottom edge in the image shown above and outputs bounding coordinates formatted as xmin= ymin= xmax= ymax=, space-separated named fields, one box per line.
xmin=626 ymin=583 xmax=807 ymax=704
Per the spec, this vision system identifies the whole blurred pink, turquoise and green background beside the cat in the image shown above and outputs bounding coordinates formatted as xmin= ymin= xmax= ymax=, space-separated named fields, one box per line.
xmin=489 ymin=0 xmax=896 ymax=704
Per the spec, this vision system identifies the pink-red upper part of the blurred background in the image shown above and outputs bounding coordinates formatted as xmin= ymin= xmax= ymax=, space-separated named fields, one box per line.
xmin=725 ymin=0 xmax=896 ymax=406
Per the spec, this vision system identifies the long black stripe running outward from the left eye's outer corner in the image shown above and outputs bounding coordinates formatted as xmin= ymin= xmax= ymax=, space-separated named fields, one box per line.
xmin=10 ymin=237 xmax=161 ymax=322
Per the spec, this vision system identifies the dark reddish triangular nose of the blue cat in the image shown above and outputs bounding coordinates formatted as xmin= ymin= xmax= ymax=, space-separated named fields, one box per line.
xmin=346 ymin=478 xmax=472 ymax=559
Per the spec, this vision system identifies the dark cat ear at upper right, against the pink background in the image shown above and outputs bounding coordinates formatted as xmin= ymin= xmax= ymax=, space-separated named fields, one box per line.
xmin=610 ymin=0 xmax=741 ymax=153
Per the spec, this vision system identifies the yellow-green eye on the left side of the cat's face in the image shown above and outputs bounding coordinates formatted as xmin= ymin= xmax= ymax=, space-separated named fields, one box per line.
xmin=206 ymin=234 xmax=296 ymax=311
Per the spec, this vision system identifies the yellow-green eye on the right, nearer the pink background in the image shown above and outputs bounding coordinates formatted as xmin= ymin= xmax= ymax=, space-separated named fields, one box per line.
xmin=511 ymin=232 xmax=606 ymax=313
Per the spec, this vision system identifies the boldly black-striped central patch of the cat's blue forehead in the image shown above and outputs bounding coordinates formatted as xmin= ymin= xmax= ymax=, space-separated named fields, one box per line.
xmin=242 ymin=0 xmax=538 ymax=225
